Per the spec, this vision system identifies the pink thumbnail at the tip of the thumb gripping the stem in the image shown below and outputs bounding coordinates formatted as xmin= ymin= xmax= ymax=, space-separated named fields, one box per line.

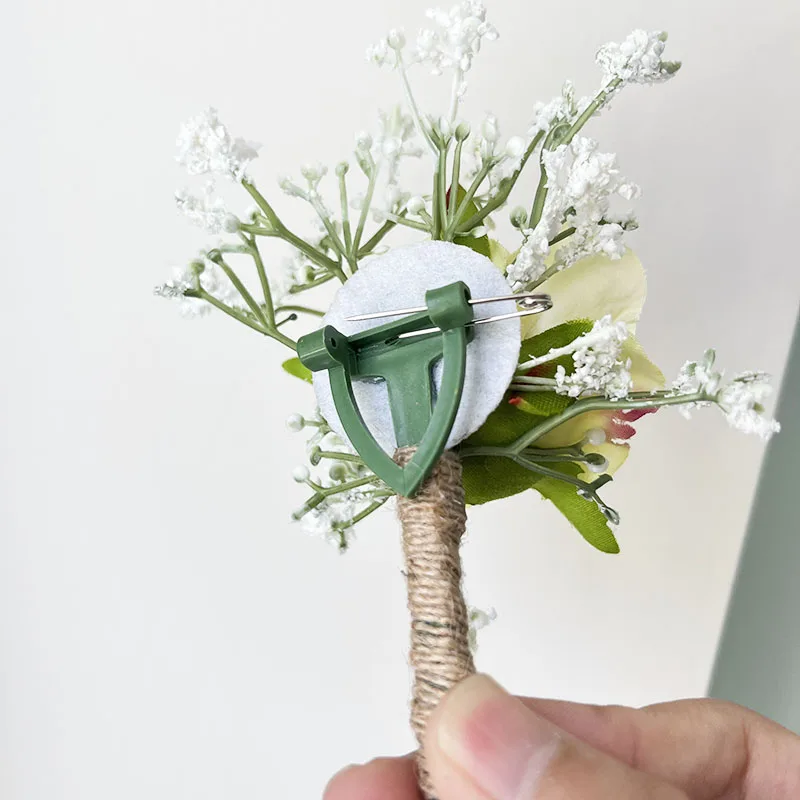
xmin=435 ymin=675 xmax=560 ymax=800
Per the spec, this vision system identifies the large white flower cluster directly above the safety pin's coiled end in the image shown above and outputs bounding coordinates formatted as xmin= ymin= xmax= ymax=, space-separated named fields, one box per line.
xmin=507 ymin=136 xmax=641 ymax=291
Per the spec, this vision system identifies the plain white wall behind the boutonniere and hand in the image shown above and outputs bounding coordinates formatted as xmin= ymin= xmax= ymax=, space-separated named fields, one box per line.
xmin=0 ymin=0 xmax=800 ymax=800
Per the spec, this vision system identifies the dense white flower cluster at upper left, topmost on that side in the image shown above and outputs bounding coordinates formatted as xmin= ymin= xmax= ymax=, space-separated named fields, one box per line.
xmin=176 ymin=108 xmax=260 ymax=180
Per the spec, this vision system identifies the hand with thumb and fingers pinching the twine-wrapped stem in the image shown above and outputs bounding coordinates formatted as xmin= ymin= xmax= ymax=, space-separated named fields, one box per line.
xmin=325 ymin=675 xmax=800 ymax=800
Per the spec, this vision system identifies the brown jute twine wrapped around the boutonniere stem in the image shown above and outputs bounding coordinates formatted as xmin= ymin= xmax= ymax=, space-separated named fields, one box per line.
xmin=395 ymin=447 xmax=475 ymax=800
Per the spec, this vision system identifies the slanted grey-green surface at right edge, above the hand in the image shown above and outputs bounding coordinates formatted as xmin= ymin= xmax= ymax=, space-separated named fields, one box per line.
xmin=709 ymin=310 xmax=800 ymax=733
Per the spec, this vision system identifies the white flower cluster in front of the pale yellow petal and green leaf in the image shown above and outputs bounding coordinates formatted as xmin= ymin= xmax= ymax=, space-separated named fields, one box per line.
xmin=555 ymin=315 xmax=633 ymax=400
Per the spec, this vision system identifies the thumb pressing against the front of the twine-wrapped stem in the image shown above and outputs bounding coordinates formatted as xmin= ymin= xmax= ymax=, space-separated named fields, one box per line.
xmin=425 ymin=675 xmax=687 ymax=800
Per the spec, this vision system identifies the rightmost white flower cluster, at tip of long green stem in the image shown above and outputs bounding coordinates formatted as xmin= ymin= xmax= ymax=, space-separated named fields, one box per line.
xmin=672 ymin=350 xmax=781 ymax=441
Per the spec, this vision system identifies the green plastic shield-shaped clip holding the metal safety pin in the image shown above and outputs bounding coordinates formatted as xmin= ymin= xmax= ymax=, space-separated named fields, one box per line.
xmin=297 ymin=281 xmax=475 ymax=497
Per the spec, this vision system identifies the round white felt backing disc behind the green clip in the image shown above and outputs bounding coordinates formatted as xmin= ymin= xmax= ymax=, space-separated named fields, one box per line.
xmin=314 ymin=241 xmax=520 ymax=453
